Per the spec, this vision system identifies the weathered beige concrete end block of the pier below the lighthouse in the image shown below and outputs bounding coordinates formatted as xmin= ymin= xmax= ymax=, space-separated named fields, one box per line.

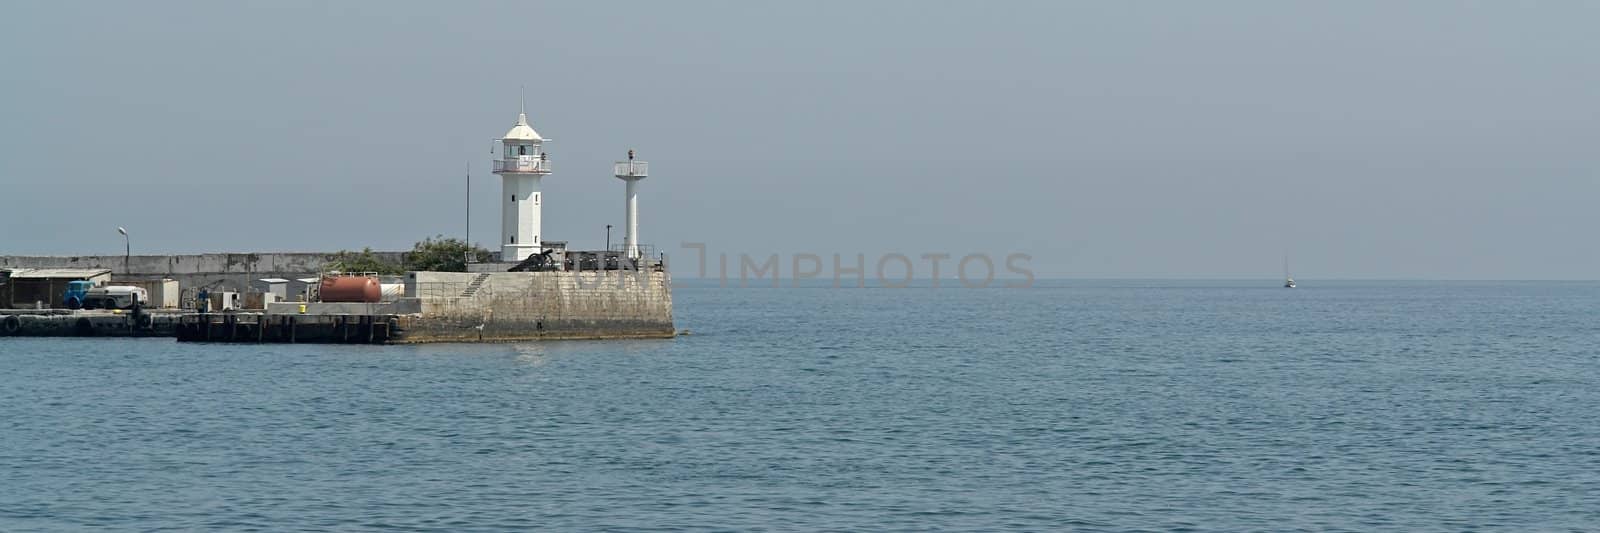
xmin=403 ymin=271 xmax=675 ymax=343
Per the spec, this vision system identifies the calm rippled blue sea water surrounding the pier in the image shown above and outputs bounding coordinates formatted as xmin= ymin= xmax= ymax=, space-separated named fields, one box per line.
xmin=0 ymin=280 xmax=1600 ymax=531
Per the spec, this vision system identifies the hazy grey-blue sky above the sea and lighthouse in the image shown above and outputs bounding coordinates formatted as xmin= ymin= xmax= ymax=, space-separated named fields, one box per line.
xmin=0 ymin=2 xmax=1600 ymax=280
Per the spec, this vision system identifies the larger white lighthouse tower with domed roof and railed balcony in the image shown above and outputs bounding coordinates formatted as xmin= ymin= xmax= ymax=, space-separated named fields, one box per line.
xmin=494 ymin=109 xmax=550 ymax=261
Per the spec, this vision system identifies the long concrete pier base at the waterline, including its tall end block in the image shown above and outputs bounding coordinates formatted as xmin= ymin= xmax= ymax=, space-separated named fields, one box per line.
xmin=0 ymin=269 xmax=677 ymax=344
